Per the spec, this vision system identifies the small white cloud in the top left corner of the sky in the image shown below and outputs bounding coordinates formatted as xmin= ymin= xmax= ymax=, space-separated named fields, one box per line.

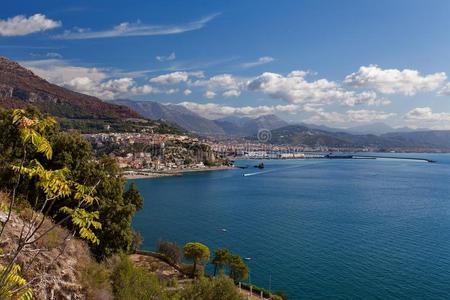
xmin=0 ymin=14 xmax=62 ymax=36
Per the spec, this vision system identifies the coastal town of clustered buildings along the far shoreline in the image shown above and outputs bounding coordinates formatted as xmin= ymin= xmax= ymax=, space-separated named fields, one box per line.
xmin=84 ymin=132 xmax=376 ymax=178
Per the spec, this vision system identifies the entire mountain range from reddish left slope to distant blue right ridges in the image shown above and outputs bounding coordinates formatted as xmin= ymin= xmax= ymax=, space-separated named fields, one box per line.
xmin=0 ymin=57 xmax=450 ymax=151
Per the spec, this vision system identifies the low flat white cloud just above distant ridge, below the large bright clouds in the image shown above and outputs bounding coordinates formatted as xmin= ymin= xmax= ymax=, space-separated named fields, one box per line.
xmin=306 ymin=109 xmax=396 ymax=125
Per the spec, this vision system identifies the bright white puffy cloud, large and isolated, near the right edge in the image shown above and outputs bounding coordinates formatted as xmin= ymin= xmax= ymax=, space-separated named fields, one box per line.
xmin=344 ymin=65 xmax=447 ymax=96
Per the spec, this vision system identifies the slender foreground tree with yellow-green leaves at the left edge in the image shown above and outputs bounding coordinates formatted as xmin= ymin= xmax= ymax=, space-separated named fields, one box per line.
xmin=0 ymin=109 xmax=101 ymax=299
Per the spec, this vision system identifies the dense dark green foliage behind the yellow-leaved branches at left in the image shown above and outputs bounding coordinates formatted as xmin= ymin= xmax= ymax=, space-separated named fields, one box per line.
xmin=0 ymin=110 xmax=143 ymax=259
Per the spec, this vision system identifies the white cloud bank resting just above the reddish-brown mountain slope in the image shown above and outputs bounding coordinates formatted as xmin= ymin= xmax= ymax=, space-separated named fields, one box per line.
xmin=22 ymin=59 xmax=157 ymax=100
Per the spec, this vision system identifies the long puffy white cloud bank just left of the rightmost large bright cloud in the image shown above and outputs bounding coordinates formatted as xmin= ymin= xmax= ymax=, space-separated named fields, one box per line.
xmin=247 ymin=71 xmax=390 ymax=106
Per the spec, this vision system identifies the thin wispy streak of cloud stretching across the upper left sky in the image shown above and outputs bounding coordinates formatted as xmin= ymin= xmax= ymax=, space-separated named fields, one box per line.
xmin=55 ymin=14 xmax=219 ymax=40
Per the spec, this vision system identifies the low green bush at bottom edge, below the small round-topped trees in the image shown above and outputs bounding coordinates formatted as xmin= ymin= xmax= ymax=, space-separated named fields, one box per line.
xmin=180 ymin=276 xmax=244 ymax=300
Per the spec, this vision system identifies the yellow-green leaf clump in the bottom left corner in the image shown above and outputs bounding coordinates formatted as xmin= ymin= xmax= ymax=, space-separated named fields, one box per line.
xmin=0 ymin=264 xmax=33 ymax=300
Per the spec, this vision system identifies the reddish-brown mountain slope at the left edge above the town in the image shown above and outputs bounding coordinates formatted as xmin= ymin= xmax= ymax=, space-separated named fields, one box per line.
xmin=0 ymin=57 xmax=140 ymax=120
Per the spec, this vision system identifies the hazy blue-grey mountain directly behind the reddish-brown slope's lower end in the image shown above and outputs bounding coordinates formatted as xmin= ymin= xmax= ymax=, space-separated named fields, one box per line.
xmin=110 ymin=99 xmax=225 ymax=135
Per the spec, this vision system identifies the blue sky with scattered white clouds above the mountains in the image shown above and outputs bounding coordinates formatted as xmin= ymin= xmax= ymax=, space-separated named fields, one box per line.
xmin=0 ymin=0 xmax=450 ymax=129
